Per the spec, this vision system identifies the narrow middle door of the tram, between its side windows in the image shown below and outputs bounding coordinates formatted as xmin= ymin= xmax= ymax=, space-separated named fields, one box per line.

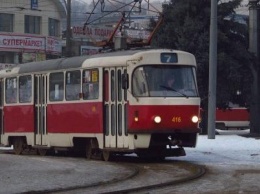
xmin=34 ymin=74 xmax=47 ymax=145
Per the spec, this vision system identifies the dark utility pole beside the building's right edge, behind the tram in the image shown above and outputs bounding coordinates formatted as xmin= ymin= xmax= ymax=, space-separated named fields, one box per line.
xmin=66 ymin=0 xmax=71 ymax=57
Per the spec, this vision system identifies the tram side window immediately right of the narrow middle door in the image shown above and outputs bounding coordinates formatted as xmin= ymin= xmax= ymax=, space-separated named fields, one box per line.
xmin=49 ymin=72 xmax=64 ymax=101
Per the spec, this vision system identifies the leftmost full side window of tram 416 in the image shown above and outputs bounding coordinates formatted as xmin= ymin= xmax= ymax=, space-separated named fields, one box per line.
xmin=5 ymin=77 xmax=17 ymax=104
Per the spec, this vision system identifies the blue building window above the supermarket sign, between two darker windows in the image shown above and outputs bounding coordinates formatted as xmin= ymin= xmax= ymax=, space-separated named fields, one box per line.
xmin=24 ymin=15 xmax=41 ymax=34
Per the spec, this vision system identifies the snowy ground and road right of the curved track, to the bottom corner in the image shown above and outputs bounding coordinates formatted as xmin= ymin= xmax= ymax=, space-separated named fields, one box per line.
xmin=146 ymin=130 xmax=260 ymax=194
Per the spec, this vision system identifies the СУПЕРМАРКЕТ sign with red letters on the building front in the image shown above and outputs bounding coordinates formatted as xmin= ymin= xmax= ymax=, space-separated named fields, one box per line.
xmin=0 ymin=33 xmax=62 ymax=54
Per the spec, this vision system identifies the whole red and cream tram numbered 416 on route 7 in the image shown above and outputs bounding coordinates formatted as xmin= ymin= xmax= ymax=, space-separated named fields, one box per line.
xmin=0 ymin=49 xmax=200 ymax=160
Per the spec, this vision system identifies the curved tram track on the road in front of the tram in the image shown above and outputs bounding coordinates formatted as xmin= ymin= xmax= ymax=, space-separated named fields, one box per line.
xmin=20 ymin=156 xmax=206 ymax=194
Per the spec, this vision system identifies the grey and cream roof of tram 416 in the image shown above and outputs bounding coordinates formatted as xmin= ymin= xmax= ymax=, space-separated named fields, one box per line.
xmin=0 ymin=49 xmax=195 ymax=76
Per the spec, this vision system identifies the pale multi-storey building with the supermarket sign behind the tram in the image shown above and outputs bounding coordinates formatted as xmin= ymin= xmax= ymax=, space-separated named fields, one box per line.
xmin=0 ymin=0 xmax=66 ymax=68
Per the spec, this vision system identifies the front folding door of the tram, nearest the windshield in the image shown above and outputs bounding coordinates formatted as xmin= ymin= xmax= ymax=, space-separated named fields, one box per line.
xmin=103 ymin=67 xmax=128 ymax=148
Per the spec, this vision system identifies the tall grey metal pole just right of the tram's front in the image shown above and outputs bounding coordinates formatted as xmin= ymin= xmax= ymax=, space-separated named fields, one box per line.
xmin=208 ymin=0 xmax=218 ymax=139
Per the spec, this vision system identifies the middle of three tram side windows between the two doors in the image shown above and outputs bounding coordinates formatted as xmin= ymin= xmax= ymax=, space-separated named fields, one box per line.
xmin=65 ymin=71 xmax=81 ymax=100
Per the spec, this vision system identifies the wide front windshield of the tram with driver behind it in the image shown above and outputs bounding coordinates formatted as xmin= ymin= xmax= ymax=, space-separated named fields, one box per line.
xmin=132 ymin=65 xmax=198 ymax=98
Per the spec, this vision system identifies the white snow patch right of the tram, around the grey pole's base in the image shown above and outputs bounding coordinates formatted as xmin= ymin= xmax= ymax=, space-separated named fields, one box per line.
xmin=181 ymin=129 xmax=260 ymax=165
